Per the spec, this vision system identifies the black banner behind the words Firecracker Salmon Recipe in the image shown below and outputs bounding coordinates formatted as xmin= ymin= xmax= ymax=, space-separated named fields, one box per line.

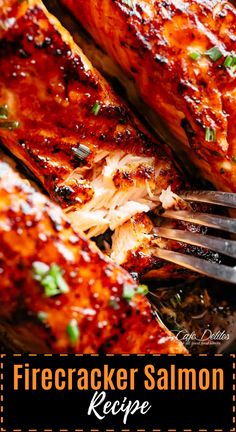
xmin=2 ymin=355 xmax=233 ymax=432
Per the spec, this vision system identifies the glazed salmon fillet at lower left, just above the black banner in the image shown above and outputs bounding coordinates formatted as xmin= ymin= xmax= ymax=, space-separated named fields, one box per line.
xmin=0 ymin=155 xmax=185 ymax=353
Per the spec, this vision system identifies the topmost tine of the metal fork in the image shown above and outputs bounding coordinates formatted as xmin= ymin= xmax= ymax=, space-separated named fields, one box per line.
xmin=180 ymin=191 xmax=236 ymax=208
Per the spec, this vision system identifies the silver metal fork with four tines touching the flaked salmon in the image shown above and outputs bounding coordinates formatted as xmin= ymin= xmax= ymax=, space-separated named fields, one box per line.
xmin=153 ymin=191 xmax=236 ymax=284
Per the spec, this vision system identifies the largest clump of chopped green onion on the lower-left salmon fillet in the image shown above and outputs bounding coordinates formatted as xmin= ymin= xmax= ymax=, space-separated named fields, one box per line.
xmin=32 ymin=261 xmax=69 ymax=297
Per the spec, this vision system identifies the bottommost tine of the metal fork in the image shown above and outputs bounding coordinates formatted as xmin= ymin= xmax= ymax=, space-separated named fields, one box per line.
xmin=155 ymin=248 xmax=236 ymax=284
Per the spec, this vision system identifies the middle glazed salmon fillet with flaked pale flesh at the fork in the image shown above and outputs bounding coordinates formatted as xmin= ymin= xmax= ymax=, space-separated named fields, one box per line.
xmin=0 ymin=0 xmax=217 ymax=279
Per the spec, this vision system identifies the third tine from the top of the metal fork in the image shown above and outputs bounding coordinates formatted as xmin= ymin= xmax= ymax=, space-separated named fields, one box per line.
xmin=153 ymin=227 xmax=236 ymax=258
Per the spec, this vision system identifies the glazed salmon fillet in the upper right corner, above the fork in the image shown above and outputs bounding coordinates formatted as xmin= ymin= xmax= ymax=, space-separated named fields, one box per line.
xmin=63 ymin=0 xmax=236 ymax=192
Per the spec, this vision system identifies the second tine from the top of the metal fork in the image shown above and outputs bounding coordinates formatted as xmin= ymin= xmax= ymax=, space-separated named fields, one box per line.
xmin=161 ymin=210 xmax=236 ymax=234
